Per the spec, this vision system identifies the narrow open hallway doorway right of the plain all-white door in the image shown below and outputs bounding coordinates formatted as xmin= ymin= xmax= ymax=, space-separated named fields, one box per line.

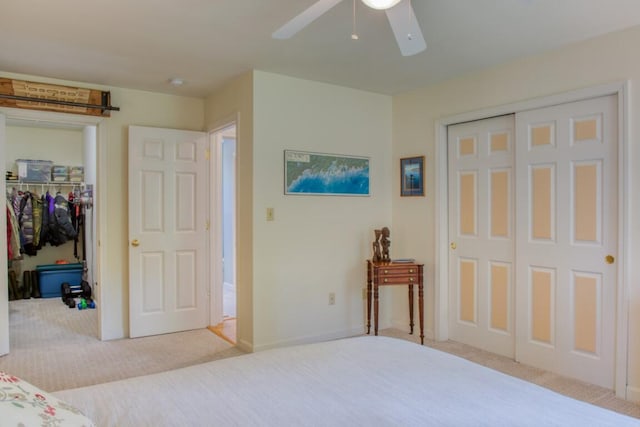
xmin=211 ymin=123 xmax=237 ymax=344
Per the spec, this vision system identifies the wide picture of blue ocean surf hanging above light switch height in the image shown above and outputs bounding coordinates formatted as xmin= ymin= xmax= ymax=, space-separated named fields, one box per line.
xmin=284 ymin=150 xmax=369 ymax=196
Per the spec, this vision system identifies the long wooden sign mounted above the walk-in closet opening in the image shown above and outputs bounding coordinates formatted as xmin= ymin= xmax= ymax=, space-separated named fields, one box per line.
xmin=0 ymin=77 xmax=120 ymax=117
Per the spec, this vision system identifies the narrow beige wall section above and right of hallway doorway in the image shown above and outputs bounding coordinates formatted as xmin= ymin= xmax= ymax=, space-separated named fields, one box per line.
xmin=205 ymin=72 xmax=254 ymax=350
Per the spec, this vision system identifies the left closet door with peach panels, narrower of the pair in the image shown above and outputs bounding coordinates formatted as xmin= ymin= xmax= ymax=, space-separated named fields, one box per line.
xmin=448 ymin=115 xmax=515 ymax=357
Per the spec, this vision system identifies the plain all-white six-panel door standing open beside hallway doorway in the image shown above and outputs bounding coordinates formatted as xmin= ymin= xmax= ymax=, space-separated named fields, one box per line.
xmin=129 ymin=126 xmax=209 ymax=337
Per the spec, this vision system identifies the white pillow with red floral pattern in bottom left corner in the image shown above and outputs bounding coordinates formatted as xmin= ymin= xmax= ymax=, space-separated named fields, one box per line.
xmin=0 ymin=371 xmax=94 ymax=427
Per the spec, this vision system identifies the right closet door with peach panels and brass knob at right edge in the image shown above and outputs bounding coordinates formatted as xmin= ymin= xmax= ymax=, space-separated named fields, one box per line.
xmin=516 ymin=96 xmax=618 ymax=388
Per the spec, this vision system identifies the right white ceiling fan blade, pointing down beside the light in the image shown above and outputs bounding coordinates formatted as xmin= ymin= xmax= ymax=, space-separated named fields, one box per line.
xmin=385 ymin=0 xmax=427 ymax=56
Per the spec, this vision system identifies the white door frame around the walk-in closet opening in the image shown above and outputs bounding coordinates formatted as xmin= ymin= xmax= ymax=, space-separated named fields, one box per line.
xmin=0 ymin=107 xmax=108 ymax=354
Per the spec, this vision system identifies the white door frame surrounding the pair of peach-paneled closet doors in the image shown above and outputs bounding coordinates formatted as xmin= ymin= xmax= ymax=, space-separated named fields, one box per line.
xmin=434 ymin=81 xmax=630 ymax=399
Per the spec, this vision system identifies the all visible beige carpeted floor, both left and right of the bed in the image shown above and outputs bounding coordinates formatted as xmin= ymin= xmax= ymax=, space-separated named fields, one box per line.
xmin=0 ymin=298 xmax=640 ymax=418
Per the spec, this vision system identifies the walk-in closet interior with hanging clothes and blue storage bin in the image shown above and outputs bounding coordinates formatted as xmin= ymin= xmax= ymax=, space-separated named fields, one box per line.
xmin=5 ymin=120 xmax=98 ymax=342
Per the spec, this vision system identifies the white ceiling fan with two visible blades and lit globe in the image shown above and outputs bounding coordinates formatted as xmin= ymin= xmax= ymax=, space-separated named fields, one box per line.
xmin=272 ymin=0 xmax=427 ymax=56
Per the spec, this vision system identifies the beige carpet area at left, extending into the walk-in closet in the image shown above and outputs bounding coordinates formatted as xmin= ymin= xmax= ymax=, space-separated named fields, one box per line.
xmin=0 ymin=298 xmax=243 ymax=391
